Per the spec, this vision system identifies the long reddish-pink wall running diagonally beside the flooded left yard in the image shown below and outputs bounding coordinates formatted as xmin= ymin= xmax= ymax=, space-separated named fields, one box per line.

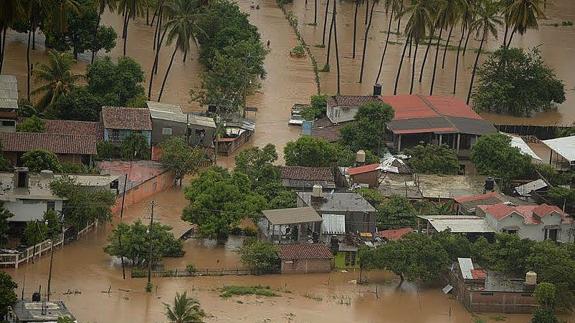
xmin=112 ymin=171 xmax=175 ymax=213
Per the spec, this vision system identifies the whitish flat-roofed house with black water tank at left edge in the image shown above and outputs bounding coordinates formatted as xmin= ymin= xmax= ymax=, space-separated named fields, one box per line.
xmin=0 ymin=167 xmax=118 ymax=226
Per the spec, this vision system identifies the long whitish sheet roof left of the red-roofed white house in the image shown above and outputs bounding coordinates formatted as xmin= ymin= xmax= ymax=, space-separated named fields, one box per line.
xmin=419 ymin=215 xmax=495 ymax=233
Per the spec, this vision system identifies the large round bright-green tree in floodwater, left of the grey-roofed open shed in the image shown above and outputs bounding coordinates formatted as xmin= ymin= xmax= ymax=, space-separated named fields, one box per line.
xmin=182 ymin=167 xmax=267 ymax=241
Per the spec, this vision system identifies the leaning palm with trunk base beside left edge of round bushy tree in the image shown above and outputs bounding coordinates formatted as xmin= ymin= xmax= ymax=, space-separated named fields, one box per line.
xmin=466 ymin=0 xmax=503 ymax=104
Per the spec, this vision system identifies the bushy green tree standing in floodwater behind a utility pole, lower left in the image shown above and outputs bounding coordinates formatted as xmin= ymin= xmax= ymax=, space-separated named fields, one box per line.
xmin=104 ymin=220 xmax=184 ymax=267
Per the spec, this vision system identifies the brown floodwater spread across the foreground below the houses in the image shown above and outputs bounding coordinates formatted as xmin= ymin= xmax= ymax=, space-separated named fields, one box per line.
xmin=2 ymin=188 xmax=528 ymax=322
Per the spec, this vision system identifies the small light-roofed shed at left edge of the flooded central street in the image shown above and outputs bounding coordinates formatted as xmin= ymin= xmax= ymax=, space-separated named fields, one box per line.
xmin=216 ymin=116 xmax=256 ymax=156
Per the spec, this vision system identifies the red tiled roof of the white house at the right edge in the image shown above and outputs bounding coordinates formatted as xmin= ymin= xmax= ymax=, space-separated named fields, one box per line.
xmin=478 ymin=203 xmax=571 ymax=224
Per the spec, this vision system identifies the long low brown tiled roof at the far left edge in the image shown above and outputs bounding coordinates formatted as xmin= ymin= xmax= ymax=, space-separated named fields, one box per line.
xmin=0 ymin=132 xmax=99 ymax=155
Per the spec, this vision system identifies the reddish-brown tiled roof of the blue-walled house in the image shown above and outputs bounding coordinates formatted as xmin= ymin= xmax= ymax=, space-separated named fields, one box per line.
xmin=102 ymin=107 xmax=152 ymax=130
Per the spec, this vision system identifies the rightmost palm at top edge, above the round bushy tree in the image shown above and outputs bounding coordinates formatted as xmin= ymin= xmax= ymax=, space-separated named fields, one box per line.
xmin=504 ymin=0 xmax=545 ymax=47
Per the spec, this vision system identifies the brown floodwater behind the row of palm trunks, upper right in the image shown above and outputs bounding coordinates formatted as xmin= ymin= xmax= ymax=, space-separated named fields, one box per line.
xmin=290 ymin=0 xmax=575 ymax=124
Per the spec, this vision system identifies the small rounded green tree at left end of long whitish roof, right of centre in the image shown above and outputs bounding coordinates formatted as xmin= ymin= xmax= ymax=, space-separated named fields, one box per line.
xmin=377 ymin=195 xmax=417 ymax=229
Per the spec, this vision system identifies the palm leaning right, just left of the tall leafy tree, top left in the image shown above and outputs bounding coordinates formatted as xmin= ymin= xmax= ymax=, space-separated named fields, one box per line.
xmin=158 ymin=0 xmax=200 ymax=101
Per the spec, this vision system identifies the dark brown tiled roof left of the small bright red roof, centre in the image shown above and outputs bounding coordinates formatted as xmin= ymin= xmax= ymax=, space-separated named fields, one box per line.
xmin=280 ymin=166 xmax=336 ymax=190
